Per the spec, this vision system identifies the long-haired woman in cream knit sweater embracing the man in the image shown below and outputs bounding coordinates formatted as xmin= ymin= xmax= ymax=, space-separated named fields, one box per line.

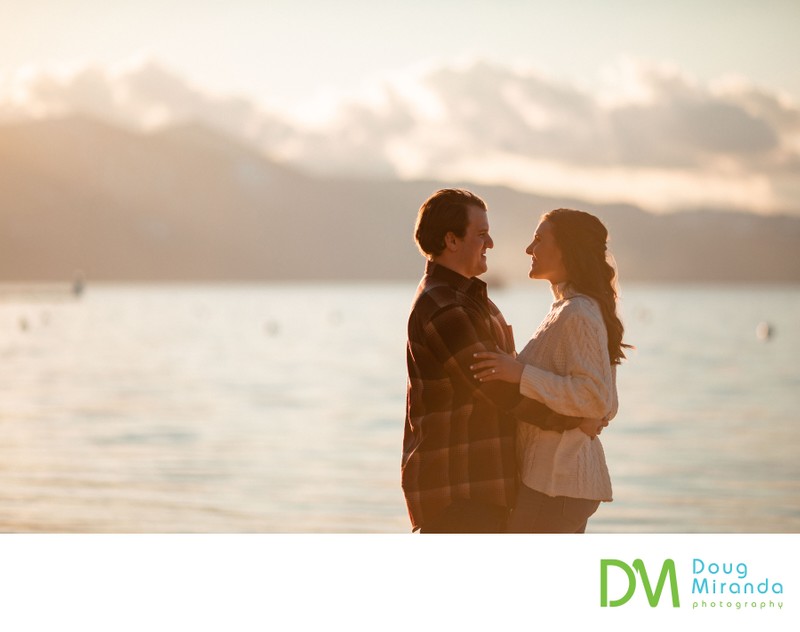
xmin=473 ymin=209 xmax=630 ymax=533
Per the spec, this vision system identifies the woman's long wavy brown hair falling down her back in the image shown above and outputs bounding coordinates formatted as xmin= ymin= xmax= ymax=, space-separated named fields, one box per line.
xmin=542 ymin=208 xmax=633 ymax=364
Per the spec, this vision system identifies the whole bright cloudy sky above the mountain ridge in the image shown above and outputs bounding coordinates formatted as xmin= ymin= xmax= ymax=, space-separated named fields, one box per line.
xmin=0 ymin=0 xmax=800 ymax=214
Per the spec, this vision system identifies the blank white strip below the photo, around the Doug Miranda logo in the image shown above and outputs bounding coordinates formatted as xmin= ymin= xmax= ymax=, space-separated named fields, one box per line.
xmin=0 ymin=534 xmax=800 ymax=632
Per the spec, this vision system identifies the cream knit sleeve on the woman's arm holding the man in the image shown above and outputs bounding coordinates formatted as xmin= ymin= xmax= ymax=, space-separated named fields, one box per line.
xmin=520 ymin=299 xmax=616 ymax=419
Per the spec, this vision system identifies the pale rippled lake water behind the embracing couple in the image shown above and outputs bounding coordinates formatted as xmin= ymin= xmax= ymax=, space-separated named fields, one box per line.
xmin=0 ymin=282 xmax=800 ymax=533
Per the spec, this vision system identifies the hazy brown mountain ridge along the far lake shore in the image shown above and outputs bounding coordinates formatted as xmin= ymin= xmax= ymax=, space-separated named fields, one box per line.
xmin=0 ymin=117 xmax=800 ymax=282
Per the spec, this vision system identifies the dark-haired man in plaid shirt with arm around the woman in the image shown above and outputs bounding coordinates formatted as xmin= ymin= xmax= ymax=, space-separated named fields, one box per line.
xmin=402 ymin=189 xmax=582 ymax=533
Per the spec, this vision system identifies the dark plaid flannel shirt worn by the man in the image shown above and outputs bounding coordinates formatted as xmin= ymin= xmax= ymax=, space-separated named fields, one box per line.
xmin=402 ymin=262 xmax=580 ymax=530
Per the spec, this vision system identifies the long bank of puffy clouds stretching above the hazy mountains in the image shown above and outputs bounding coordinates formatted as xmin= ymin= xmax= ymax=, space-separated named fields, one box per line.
xmin=0 ymin=58 xmax=800 ymax=212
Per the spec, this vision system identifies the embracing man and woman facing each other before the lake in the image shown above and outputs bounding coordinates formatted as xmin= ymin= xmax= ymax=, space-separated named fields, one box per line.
xmin=402 ymin=189 xmax=628 ymax=533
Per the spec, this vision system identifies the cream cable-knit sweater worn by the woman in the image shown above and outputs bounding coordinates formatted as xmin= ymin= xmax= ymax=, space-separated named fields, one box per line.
xmin=517 ymin=283 xmax=617 ymax=501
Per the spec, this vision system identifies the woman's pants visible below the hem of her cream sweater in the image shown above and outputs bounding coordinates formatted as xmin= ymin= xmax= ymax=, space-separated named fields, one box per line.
xmin=508 ymin=485 xmax=600 ymax=533
